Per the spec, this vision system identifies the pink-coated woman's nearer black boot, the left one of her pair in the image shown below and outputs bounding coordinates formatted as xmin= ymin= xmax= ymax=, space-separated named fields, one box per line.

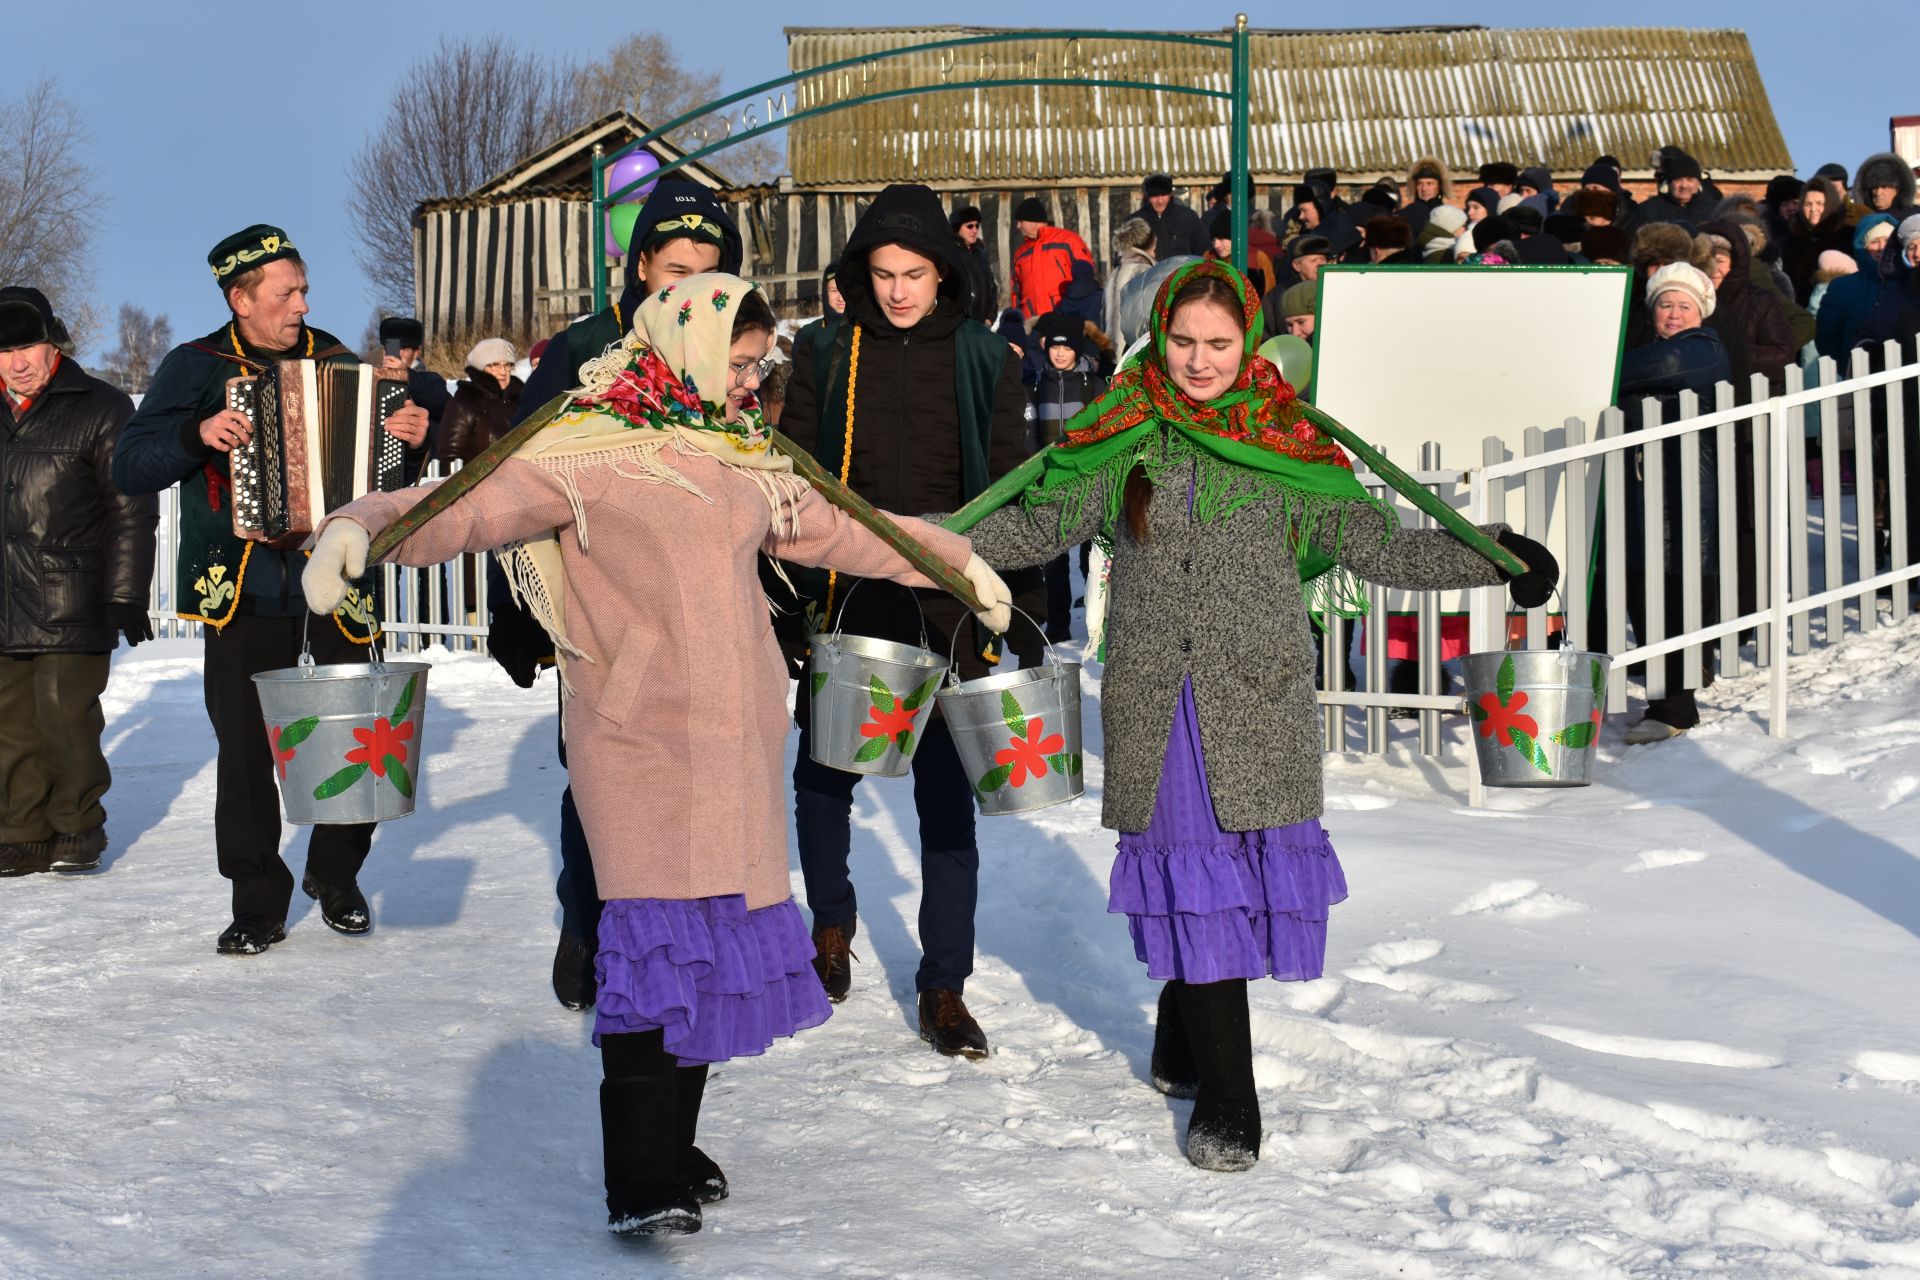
xmin=601 ymin=1031 xmax=701 ymax=1236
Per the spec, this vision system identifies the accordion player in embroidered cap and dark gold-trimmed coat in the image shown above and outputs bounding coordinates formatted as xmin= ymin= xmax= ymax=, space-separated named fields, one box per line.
xmin=113 ymin=223 xmax=426 ymax=956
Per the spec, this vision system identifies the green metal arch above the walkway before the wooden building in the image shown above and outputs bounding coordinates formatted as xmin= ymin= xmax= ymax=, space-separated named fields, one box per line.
xmin=591 ymin=13 xmax=1252 ymax=311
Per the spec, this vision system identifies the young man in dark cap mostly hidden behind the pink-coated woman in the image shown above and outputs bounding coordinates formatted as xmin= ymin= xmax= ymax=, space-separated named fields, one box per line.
xmin=488 ymin=178 xmax=743 ymax=1009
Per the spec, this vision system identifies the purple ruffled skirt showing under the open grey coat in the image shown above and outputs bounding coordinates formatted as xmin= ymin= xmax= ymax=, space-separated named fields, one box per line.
xmin=1106 ymin=679 xmax=1346 ymax=983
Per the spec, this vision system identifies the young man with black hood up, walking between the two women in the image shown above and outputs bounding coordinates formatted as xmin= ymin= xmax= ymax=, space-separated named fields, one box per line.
xmin=780 ymin=184 xmax=1039 ymax=1057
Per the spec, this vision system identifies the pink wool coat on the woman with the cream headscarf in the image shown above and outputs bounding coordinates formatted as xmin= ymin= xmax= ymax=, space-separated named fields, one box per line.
xmin=334 ymin=449 xmax=972 ymax=910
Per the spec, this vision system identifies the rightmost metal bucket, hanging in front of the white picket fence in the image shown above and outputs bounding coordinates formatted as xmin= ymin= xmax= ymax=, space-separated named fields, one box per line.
xmin=1461 ymin=649 xmax=1613 ymax=787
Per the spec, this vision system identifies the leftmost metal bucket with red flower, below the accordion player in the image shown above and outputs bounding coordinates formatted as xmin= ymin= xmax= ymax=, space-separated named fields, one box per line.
xmin=253 ymin=656 xmax=432 ymax=825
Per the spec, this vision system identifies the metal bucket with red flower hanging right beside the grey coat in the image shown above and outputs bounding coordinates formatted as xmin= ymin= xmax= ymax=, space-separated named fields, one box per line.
xmin=935 ymin=614 xmax=1087 ymax=818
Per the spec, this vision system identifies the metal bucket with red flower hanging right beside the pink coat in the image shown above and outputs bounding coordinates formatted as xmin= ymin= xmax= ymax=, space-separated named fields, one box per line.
xmin=806 ymin=633 xmax=947 ymax=777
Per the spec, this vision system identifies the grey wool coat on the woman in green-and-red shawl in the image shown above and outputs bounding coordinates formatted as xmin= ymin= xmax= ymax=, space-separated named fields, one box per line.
xmin=967 ymin=454 xmax=1507 ymax=831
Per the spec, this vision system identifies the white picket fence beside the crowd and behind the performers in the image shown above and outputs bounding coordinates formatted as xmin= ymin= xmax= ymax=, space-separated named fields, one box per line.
xmin=152 ymin=344 xmax=1920 ymax=782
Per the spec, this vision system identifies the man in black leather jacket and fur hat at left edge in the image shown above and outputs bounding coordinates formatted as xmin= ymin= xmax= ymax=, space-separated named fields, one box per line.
xmin=0 ymin=288 xmax=157 ymax=875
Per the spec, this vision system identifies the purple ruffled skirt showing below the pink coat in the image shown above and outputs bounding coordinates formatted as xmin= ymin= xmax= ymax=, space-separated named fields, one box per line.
xmin=593 ymin=894 xmax=833 ymax=1067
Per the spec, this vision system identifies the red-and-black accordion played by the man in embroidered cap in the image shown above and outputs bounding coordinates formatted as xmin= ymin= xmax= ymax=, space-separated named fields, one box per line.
xmin=227 ymin=361 xmax=407 ymax=551
